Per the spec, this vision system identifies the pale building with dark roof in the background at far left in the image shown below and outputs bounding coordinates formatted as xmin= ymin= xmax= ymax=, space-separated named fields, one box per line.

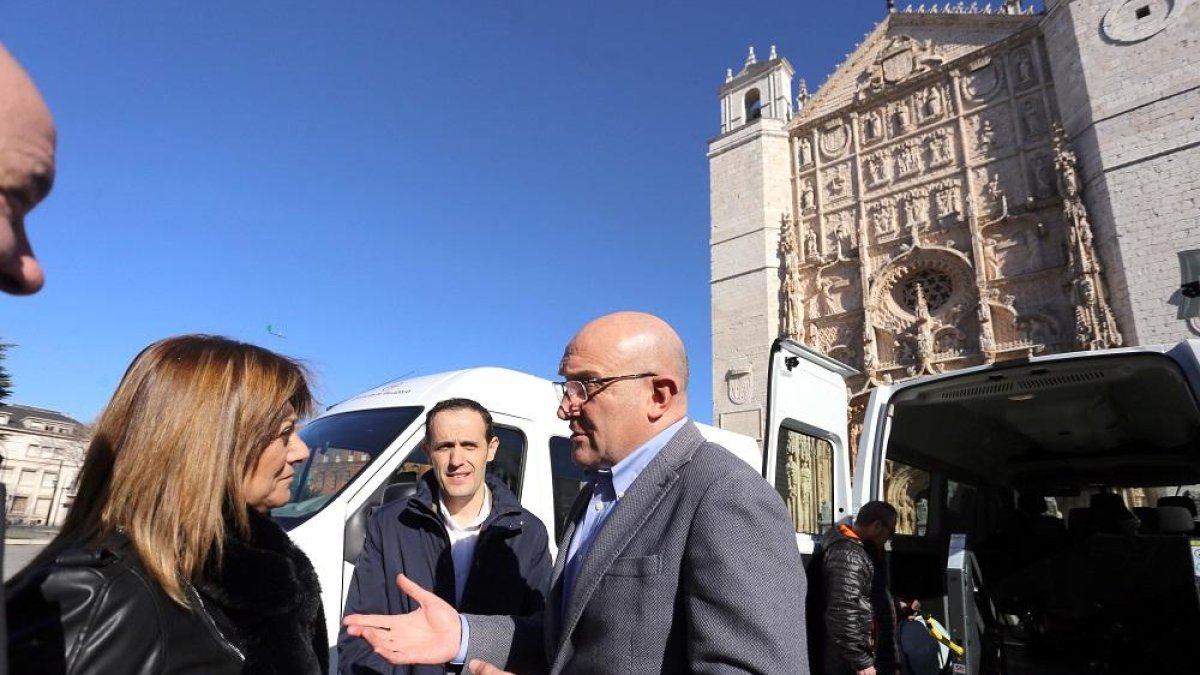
xmin=0 ymin=405 xmax=90 ymax=526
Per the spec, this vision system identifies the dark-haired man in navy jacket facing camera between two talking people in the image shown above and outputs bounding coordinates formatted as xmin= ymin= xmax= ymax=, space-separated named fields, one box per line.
xmin=337 ymin=399 xmax=552 ymax=675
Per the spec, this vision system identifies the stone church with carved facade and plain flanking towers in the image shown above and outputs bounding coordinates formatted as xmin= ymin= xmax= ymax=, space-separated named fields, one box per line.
xmin=708 ymin=0 xmax=1200 ymax=446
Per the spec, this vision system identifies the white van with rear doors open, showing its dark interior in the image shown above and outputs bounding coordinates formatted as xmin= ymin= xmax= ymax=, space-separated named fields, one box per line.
xmin=763 ymin=340 xmax=1200 ymax=675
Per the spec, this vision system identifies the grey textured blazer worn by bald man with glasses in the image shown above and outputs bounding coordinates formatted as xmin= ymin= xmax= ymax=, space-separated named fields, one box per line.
xmin=467 ymin=423 xmax=809 ymax=675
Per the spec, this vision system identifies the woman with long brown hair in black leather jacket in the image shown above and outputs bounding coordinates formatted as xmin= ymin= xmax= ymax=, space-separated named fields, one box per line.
xmin=5 ymin=335 xmax=329 ymax=675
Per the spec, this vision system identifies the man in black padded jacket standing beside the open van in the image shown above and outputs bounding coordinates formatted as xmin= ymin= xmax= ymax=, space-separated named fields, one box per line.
xmin=809 ymin=501 xmax=899 ymax=675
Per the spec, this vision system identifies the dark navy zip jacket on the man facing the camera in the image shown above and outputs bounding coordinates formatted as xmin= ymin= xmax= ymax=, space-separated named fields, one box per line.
xmin=337 ymin=471 xmax=553 ymax=675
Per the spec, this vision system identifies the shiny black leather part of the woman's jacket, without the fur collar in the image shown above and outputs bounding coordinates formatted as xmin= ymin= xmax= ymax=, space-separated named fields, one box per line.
xmin=6 ymin=533 xmax=244 ymax=675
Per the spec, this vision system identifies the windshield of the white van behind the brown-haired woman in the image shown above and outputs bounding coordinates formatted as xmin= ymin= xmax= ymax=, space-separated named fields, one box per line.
xmin=271 ymin=406 xmax=424 ymax=530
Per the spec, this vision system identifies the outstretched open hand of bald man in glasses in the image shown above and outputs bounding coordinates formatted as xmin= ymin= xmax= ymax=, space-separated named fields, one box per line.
xmin=342 ymin=574 xmax=462 ymax=665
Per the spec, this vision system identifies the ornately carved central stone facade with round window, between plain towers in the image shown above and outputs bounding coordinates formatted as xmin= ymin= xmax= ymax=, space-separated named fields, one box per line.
xmin=779 ymin=16 xmax=1122 ymax=468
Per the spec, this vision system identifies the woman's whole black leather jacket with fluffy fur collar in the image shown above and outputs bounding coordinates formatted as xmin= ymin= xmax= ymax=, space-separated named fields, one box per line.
xmin=6 ymin=510 xmax=329 ymax=675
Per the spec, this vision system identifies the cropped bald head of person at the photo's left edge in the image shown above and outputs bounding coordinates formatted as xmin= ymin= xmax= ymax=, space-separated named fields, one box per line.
xmin=0 ymin=46 xmax=55 ymax=294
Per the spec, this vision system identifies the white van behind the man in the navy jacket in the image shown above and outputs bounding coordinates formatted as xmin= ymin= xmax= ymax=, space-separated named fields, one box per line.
xmin=272 ymin=368 xmax=761 ymax=653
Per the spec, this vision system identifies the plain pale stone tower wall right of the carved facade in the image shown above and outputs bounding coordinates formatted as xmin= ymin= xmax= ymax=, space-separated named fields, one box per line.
xmin=1043 ymin=0 xmax=1200 ymax=345
